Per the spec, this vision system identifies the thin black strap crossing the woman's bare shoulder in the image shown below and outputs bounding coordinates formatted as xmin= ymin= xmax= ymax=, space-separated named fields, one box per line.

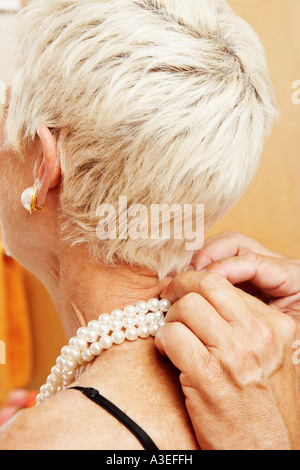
xmin=68 ymin=387 xmax=159 ymax=450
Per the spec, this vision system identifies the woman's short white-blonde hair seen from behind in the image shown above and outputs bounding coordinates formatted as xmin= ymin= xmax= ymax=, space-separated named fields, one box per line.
xmin=6 ymin=0 xmax=276 ymax=278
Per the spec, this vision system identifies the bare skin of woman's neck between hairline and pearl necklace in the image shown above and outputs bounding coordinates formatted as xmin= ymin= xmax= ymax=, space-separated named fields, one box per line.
xmin=45 ymin=245 xmax=171 ymax=339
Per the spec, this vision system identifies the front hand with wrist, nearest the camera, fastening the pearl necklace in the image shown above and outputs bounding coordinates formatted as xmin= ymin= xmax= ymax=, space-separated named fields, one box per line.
xmin=155 ymin=270 xmax=300 ymax=450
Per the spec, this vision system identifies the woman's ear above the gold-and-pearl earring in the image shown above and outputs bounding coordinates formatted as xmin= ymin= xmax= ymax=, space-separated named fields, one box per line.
xmin=34 ymin=126 xmax=61 ymax=207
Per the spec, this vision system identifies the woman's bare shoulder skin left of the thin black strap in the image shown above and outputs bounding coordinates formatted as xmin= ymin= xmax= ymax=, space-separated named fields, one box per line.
xmin=0 ymin=390 xmax=142 ymax=450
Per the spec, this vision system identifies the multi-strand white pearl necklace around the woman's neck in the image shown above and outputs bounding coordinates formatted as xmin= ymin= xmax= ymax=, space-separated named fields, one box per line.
xmin=36 ymin=299 xmax=171 ymax=405
